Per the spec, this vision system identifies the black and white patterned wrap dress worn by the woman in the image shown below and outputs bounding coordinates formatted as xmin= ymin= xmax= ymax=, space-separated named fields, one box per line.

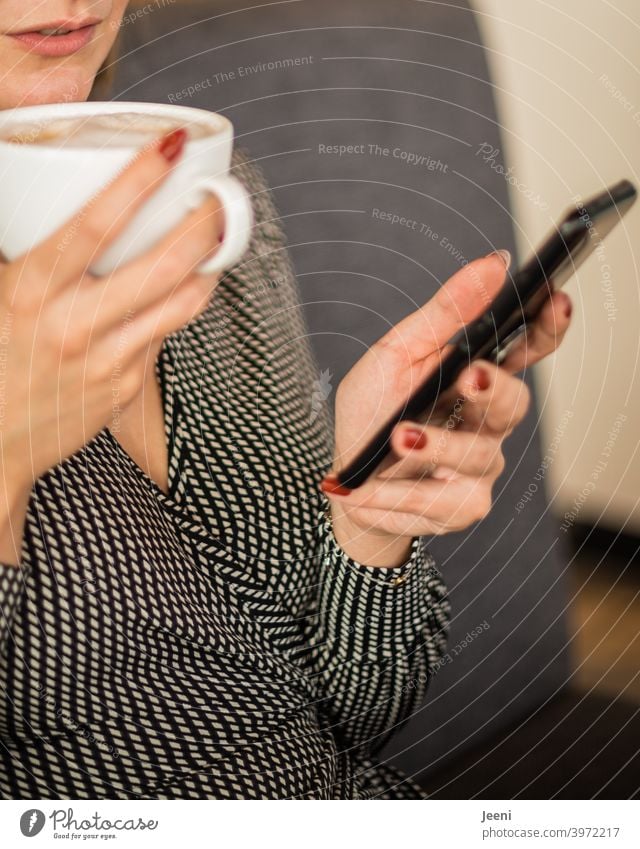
xmin=0 ymin=151 xmax=449 ymax=799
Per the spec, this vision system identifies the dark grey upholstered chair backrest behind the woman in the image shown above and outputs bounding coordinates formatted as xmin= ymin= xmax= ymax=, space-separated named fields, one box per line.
xmin=110 ymin=0 xmax=567 ymax=773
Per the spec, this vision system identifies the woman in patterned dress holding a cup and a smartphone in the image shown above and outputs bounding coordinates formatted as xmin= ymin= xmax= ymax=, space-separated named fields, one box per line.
xmin=0 ymin=0 xmax=570 ymax=799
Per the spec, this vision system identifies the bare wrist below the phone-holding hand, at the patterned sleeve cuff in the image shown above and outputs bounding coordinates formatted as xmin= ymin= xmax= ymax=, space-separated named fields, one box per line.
xmin=330 ymin=502 xmax=414 ymax=569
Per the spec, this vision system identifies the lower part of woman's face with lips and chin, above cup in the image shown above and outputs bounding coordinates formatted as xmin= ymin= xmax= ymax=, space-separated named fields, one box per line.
xmin=0 ymin=0 xmax=128 ymax=109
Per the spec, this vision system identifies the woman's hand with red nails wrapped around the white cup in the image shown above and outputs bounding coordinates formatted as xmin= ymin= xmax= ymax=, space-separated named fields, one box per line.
xmin=0 ymin=131 xmax=223 ymax=562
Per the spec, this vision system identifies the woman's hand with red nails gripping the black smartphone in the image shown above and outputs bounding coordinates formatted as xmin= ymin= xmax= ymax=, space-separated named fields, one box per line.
xmin=322 ymin=253 xmax=571 ymax=567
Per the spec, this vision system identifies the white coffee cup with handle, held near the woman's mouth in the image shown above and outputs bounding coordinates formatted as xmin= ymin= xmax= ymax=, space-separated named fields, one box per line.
xmin=0 ymin=101 xmax=253 ymax=276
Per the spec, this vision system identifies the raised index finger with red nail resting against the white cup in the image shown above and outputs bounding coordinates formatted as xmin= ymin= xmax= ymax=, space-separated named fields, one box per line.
xmin=25 ymin=128 xmax=187 ymax=288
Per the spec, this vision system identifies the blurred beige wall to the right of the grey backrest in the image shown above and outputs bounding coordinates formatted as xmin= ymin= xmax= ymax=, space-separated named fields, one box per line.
xmin=474 ymin=0 xmax=640 ymax=532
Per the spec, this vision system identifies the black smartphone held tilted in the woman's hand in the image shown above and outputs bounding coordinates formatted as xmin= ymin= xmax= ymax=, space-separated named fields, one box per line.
xmin=338 ymin=180 xmax=637 ymax=489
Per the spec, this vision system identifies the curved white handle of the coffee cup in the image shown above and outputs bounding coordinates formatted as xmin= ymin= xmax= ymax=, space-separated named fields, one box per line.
xmin=189 ymin=175 xmax=253 ymax=274
